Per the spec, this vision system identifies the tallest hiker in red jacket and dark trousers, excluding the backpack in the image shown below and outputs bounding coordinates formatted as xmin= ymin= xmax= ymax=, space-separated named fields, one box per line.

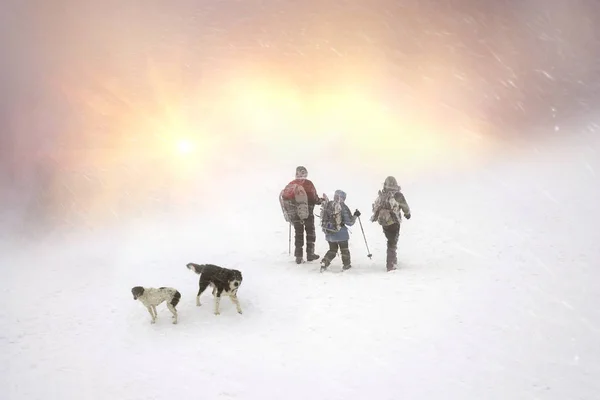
xmin=290 ymin=166 xmax=321 ymax=264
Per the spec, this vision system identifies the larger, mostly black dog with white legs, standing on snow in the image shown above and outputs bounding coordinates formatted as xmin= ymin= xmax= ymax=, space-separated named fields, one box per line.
xmin=187 ymin=263 xmax=242 ymax=315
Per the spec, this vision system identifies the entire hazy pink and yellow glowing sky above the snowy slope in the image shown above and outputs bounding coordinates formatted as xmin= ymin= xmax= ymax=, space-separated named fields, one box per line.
xmin=0 ymin=1 xmax=600 ymax=244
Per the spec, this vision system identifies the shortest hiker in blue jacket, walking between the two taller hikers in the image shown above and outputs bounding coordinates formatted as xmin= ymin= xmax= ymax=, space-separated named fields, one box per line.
xmin=321 ymin=190 xmax=360 ymax=272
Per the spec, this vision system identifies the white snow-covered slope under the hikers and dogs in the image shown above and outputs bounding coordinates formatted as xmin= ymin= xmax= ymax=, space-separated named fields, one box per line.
xmin=0 ymin=126 xmax=600 ymax=400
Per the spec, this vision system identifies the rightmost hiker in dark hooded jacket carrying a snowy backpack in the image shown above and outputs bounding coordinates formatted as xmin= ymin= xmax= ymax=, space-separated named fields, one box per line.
xmin=371 ymin=176 xmax=410 ymax=272
